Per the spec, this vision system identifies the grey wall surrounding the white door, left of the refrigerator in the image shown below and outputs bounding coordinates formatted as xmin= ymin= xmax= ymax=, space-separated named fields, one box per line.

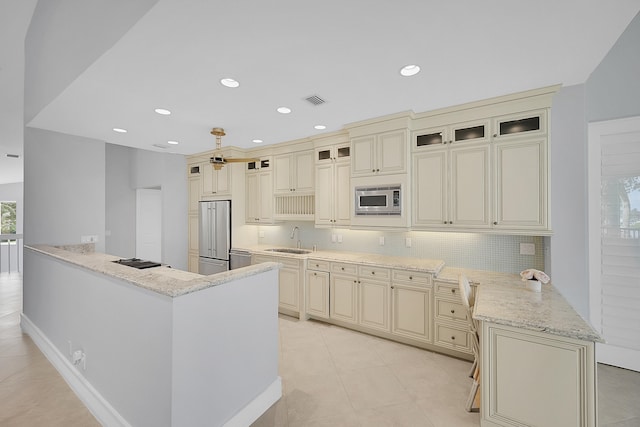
xmin=105 ymin=144 xmax=188 ymax=270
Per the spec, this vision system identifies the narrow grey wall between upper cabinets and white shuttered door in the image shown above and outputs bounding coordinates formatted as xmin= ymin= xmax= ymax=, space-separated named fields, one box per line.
xmin=547 ymin=85 xmax=589 ymax=318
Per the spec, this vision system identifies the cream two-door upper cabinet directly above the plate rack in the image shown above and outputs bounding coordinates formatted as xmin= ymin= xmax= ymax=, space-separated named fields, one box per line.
xmin=273 ymin=150 xmax=314 ymax=194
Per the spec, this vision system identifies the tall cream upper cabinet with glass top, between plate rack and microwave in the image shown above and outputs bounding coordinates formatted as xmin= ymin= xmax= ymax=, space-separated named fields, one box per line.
xmin=315 ymin=144 xmax=351 ymax=226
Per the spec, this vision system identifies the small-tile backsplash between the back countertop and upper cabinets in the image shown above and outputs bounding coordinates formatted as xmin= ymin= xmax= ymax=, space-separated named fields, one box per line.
xmin=255 ymin=222 xmax=545 ymax=273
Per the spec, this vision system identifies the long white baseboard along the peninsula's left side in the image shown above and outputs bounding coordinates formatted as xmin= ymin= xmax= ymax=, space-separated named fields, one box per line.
xmin=20 ymin=313 xmax=131 ymax=427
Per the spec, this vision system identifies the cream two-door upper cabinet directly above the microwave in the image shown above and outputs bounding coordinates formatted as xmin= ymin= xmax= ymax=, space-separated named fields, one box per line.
xmin=351 ymin=130 xmax=407 ymax=176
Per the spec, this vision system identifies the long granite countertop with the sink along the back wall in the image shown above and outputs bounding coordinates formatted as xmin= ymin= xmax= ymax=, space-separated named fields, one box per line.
xmin=234 ymin=245 xmax=444 ymax=275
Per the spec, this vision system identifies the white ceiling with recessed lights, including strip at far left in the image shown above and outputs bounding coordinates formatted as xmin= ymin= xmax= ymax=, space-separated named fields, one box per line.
xmin=0 ymin=0 xmax=640 ymax=183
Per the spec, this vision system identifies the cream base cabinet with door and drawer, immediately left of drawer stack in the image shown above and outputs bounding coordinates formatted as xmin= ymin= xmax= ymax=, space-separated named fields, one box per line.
xmin=391 ymin=270 xmax=433 ymax=343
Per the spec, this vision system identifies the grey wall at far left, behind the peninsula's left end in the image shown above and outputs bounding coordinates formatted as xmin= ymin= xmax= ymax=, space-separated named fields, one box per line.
xmin=24 ymin=128 xmax=105 ymax=252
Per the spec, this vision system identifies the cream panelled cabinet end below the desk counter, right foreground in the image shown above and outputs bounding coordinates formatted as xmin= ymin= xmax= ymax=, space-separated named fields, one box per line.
xmin=480 ymin=322 xmax=597 ymax=427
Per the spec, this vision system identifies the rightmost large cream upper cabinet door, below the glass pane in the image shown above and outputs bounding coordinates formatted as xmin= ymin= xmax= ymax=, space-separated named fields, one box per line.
xmin=493 ymin=137 xmax=549 ymax=230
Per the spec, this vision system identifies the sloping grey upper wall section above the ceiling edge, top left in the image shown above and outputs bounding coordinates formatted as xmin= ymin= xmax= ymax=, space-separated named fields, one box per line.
xmin=24 ymin=0 xmax=158 ymax=123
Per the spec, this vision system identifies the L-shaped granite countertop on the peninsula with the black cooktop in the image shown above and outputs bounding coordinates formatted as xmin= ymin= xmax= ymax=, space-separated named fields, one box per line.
xmin=25 ymin=243 xmax=280 ymax=297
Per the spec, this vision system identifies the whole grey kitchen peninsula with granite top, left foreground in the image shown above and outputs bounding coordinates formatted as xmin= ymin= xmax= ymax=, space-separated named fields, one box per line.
xmin=21 ymin=244 xmax=282 ymax=426
